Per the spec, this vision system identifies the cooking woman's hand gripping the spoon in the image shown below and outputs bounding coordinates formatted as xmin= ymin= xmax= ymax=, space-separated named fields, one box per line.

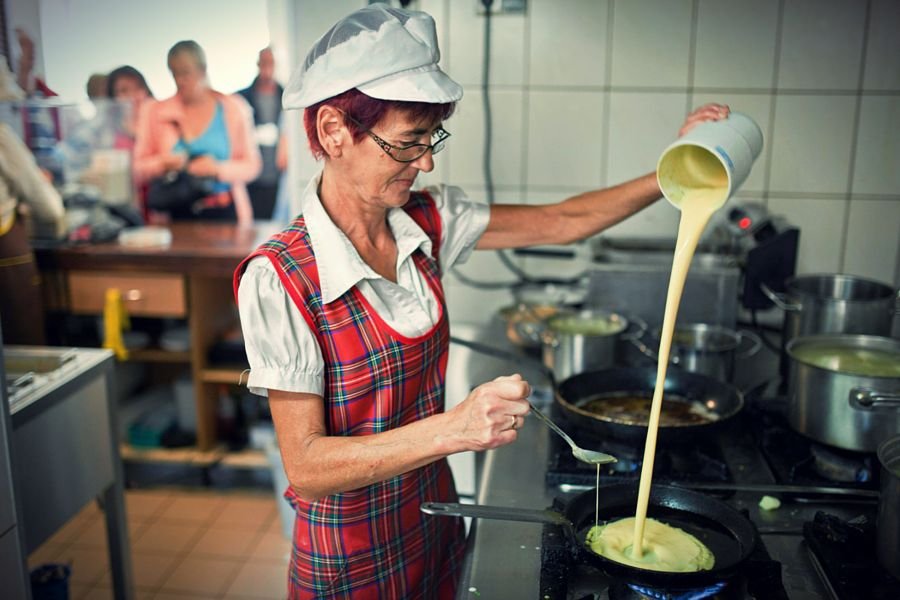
xmin=447 ymin=374 xmax=531 ymax=451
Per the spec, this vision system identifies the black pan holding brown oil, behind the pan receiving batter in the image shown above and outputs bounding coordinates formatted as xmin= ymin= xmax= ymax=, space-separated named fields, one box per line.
xmin=451 ymin=337 xmax=744 ymax=445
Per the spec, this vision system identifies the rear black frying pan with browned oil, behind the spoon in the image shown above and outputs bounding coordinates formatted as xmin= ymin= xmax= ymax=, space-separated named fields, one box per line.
xmin=450 ymin=336 xmax=744 ymax=445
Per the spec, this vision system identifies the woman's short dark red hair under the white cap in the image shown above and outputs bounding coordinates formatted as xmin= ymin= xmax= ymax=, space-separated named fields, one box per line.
xmin=303 ymin=88 xmax=456 ymax=160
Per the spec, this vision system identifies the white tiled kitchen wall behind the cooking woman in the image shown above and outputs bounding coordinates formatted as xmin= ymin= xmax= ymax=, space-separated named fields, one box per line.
xmin=296 ymin=0 xmax=900 ymax=322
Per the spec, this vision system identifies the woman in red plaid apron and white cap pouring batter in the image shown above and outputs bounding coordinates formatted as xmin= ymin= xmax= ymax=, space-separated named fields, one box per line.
xmin=235 ymin=4 xmax=727 ymax=598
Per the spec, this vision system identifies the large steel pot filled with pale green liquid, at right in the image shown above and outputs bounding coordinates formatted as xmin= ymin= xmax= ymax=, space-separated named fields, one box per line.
xmin=787 ymin=335 xmax=900 ymax=452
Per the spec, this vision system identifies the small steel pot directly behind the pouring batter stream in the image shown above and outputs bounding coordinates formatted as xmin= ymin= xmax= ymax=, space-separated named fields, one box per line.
xmin=632 ymin=323 xmax=762 ymax=382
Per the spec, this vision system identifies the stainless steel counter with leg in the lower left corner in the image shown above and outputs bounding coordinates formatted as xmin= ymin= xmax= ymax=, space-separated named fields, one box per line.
xmin=4 ymin=346 xmax=134 ymax=600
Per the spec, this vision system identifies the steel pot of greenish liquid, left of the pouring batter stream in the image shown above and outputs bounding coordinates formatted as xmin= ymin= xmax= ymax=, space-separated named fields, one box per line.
xmin=542 ymin=308 xmax=647 ymax=381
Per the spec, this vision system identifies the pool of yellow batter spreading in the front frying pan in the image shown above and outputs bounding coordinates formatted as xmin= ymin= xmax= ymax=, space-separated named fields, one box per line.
xmin=587 ymin=517 xmax=715 ymax=573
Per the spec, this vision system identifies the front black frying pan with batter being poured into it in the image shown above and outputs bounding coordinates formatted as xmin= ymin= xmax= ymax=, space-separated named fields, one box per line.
xmin=420 ymin=482 xmax=757 ymax=590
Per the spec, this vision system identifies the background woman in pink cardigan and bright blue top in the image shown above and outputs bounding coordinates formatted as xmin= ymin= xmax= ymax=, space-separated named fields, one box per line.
xmin=134 ymin=40 xmax=262 ymax=226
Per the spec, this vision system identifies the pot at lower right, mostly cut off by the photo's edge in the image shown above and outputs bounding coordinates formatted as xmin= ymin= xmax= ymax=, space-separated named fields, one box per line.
xmin=875 ymin=435 xmax=900 ymax=579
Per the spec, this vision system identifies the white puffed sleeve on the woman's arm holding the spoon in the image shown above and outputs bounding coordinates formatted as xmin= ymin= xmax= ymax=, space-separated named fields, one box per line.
xmin=238 ymin=257 xmax=325 ymax=396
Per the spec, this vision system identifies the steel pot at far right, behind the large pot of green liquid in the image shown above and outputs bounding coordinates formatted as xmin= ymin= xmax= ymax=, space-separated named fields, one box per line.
xmin=761 ymin=275 xmax=900 ymax=380
